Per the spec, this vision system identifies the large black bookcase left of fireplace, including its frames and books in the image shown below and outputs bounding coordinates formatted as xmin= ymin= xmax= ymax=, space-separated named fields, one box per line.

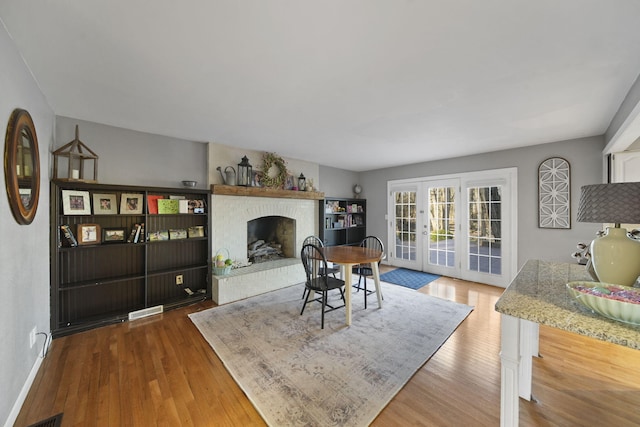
xmin=50 ymin=180 xmax=211 ymax=337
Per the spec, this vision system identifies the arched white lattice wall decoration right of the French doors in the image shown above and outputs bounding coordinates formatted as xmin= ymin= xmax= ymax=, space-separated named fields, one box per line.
xmin=538 ymin=157 xmax=571 ymax=228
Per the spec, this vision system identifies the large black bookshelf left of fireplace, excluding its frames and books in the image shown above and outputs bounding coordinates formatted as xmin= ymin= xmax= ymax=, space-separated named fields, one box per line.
xmin=50 ymin=180 xmax=211 ymax=337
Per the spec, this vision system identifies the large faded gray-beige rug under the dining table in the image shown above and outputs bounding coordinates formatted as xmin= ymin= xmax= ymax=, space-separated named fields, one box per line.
xmin=189 ymin=283 xmax=473 ymax=427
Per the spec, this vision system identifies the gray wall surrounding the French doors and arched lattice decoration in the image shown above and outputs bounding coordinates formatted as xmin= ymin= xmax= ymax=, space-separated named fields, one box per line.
xmin=360 ymin=137 xmax=604 ymax=268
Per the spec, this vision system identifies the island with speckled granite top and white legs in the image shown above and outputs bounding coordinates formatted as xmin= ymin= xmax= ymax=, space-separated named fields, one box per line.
xmin=495 ymin=260 xmax=640 ymax=427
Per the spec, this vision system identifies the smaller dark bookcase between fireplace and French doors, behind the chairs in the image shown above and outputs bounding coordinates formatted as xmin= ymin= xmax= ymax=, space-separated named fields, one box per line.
xmin=318 ymin=198 xmax=367 ymax=246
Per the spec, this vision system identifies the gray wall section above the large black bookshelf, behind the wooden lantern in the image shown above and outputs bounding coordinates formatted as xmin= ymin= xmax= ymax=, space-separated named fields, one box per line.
xmin=55 ymin=116 xmax=208 ymax=188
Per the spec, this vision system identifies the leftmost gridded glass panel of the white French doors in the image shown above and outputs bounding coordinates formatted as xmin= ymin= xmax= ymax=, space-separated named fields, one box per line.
xmin=394 ymin=191 xmax=416 ymax=261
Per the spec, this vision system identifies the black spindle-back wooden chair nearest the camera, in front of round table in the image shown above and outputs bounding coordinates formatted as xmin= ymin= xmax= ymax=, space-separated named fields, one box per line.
xmin=300 ymin=244 xmax=345 ymax=329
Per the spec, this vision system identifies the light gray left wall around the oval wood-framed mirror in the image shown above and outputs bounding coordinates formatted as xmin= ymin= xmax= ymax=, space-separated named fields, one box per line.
xmin=0 ymin=22 xmax=54 ymax=425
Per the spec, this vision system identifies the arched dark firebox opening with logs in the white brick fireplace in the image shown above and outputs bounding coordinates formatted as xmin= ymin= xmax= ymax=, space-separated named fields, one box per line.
xmin=247 ymin=215 xmax=296 ymax=264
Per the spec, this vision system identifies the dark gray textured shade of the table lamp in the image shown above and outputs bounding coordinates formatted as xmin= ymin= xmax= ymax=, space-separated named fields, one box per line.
xmin=578 ymin=182 xmax=640 ymax=224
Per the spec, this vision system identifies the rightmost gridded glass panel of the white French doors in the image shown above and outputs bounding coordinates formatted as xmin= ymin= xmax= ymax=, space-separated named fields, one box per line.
xmin=467 ymin=186 xmax=502 ymax=275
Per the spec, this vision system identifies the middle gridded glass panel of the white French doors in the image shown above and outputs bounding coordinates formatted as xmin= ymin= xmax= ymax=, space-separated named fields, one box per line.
xmin=428 ymin=187 xmax=455 ymax=267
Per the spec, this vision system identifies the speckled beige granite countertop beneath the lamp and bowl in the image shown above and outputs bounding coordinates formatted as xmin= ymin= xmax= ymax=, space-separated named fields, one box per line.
xmin=495 ymin=260 xmax=640 ymax=350
